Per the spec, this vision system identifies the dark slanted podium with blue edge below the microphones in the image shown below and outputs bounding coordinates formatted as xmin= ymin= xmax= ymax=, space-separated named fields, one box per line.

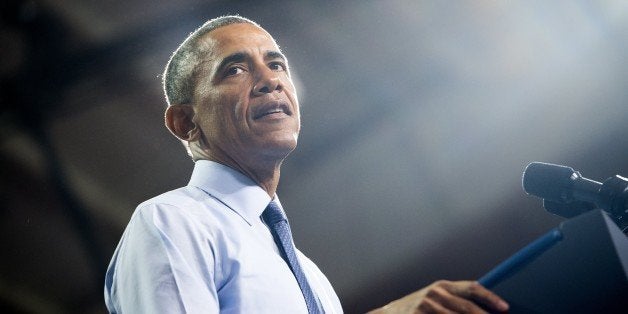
xmin=478 ymin=210 xmax=628 ymax=313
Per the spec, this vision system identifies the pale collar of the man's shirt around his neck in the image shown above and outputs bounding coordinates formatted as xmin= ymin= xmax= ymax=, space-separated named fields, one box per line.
xmin=188 ymin=160 xmax=279 ymax=225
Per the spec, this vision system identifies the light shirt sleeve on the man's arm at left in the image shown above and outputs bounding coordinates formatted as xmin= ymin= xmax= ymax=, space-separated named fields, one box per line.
xmin=105 ymin=204 xmax=220 ymax=313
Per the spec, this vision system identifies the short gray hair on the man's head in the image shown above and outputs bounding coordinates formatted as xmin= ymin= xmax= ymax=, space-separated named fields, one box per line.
xmin=163 ymin=15 xmax=259 ymax=106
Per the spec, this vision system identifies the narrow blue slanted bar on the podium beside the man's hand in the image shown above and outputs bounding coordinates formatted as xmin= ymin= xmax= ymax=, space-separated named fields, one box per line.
xmin=478 ymin=228 xmax=563 ymax=289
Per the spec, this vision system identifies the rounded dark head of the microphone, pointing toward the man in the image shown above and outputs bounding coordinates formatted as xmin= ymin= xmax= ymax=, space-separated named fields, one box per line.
xmin=522 ymin=162 xmax=579 ymax=203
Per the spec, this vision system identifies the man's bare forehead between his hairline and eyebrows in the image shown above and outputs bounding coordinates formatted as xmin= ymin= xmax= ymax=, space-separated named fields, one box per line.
xmin=201 ymin=23 xmax=279 ymax=59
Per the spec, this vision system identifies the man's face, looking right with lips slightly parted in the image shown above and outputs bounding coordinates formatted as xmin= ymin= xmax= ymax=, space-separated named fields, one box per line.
xmin=193 ymin=23 xmax=300 ymax=166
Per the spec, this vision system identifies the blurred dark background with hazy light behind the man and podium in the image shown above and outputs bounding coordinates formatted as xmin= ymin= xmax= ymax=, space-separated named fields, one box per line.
xmin=0 ymin=0 xmax=628 ymax=313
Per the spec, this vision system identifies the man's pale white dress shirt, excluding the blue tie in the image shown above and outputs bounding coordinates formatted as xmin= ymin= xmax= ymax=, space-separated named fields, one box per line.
xmin=105 ymin=160 xmax=342 ymax=313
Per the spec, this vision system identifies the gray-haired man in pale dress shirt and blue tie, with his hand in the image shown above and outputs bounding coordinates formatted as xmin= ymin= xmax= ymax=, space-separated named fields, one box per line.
xmin=105 ymin=16 xmax=507 ymax=313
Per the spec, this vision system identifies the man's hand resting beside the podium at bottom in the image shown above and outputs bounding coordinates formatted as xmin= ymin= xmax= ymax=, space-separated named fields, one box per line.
xmin=369 ymin=280 xmax=508 ymax=314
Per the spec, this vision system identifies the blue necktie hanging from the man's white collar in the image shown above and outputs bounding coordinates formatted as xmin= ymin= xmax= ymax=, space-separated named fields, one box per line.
xmin=262 ymin=201 xmax=323 ymax=314
